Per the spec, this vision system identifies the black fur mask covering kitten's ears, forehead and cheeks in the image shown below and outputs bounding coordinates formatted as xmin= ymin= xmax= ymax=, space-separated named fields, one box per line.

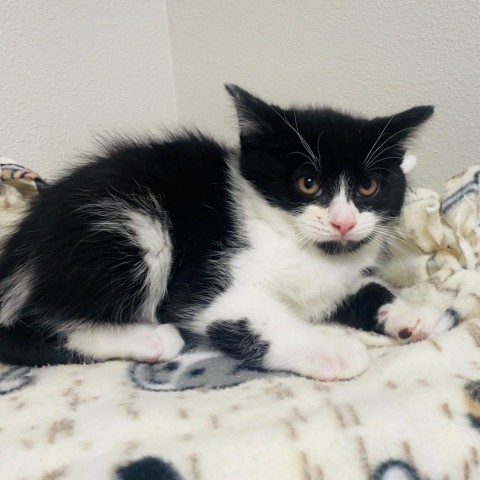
xmin=228 ymin=86 xmax=433 ymax=221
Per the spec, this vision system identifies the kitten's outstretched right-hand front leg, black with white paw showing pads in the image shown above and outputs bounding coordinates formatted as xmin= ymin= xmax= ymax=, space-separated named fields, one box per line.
xmin=333 ymin=278 xmax=458 ymax=342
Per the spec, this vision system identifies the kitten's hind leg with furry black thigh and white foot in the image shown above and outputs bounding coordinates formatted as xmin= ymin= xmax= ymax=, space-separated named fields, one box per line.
xmin=0 ymin=188 xmax=188 ymax=365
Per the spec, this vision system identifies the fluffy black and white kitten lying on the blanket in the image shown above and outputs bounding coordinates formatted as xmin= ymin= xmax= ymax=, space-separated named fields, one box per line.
xmin=0 ymin=86 xmax=455 ymax=380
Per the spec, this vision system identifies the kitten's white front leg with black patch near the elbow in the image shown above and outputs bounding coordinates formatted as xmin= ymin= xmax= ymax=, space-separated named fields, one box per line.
xmin=195 ymin=288 xmax=368 ymax=380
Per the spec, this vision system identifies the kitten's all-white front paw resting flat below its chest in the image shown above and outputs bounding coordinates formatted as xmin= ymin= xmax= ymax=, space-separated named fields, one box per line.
xmin=275 ymin=334 xmax=369 ymax=381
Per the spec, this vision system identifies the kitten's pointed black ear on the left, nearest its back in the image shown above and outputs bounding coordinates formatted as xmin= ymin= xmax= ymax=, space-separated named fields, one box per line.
xmin=225 ymin=84 xmax=275 ymax=144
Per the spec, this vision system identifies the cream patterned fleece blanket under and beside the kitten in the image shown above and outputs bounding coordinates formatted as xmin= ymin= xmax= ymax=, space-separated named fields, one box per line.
xmin=0 ymin=162 xmax=480 ymax=480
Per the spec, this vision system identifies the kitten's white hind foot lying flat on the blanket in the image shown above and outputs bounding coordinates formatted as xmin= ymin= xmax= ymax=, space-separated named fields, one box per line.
xmin=65 ymin=324 xmax=184 ymax=363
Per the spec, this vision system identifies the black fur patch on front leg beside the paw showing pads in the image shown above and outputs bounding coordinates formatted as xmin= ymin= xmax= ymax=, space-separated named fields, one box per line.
xmin=332 ymin=282 xmax=395 ymax=333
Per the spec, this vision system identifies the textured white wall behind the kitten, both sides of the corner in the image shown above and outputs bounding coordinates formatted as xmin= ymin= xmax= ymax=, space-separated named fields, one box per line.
xmin=0 ymin=0 xmax=480 ymax=188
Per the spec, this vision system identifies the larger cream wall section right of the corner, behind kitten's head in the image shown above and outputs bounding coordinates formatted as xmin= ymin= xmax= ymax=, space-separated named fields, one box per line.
xmin=167 ymin=0 xmax=480 ymax=188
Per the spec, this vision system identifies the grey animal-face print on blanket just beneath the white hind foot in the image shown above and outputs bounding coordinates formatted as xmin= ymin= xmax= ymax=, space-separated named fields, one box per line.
xmin=129 ymin=351 xmax=287 ymax=392
